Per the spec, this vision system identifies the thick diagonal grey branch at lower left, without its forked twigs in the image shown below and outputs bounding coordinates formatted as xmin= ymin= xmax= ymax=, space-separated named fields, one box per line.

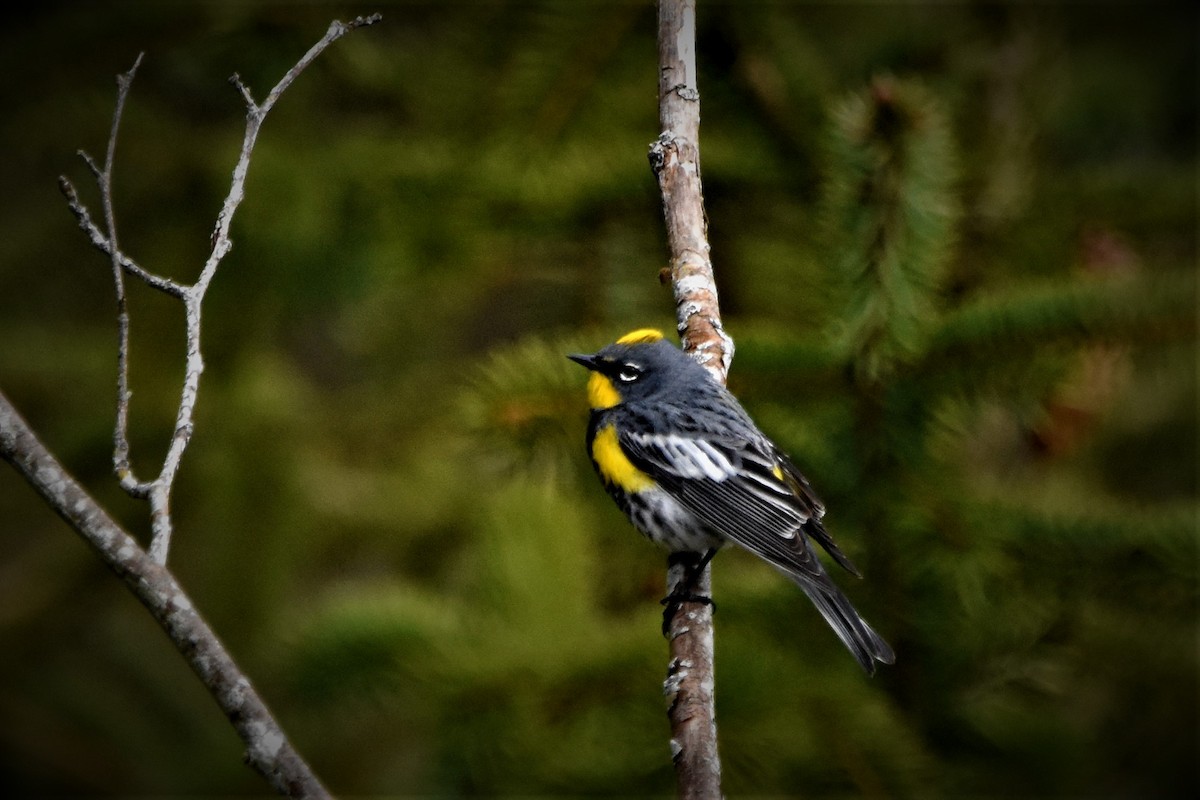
xmin=0 ymin=392 xmax=329 ymax=798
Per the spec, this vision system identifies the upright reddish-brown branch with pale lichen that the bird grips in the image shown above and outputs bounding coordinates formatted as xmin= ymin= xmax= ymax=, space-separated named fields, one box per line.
xmin=649 ymin=0 xmax=733 ymax=800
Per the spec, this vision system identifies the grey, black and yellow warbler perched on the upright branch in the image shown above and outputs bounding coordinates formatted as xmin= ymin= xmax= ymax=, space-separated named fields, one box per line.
xmin=568 ymin=329 xmax=895 ymax=674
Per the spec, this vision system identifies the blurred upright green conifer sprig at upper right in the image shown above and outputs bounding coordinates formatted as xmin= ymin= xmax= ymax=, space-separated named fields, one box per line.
xmin=824 ymin=78 xmax=958 ymax=384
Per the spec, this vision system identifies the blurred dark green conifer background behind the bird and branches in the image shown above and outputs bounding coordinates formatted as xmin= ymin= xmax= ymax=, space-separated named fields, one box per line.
xmin=0 ymin=0 xmax=1198 ymax=798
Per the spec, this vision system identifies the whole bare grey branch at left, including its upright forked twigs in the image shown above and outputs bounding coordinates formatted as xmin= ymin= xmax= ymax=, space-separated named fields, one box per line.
xmin=0 ymin=14 xmax=380 ymax=798
